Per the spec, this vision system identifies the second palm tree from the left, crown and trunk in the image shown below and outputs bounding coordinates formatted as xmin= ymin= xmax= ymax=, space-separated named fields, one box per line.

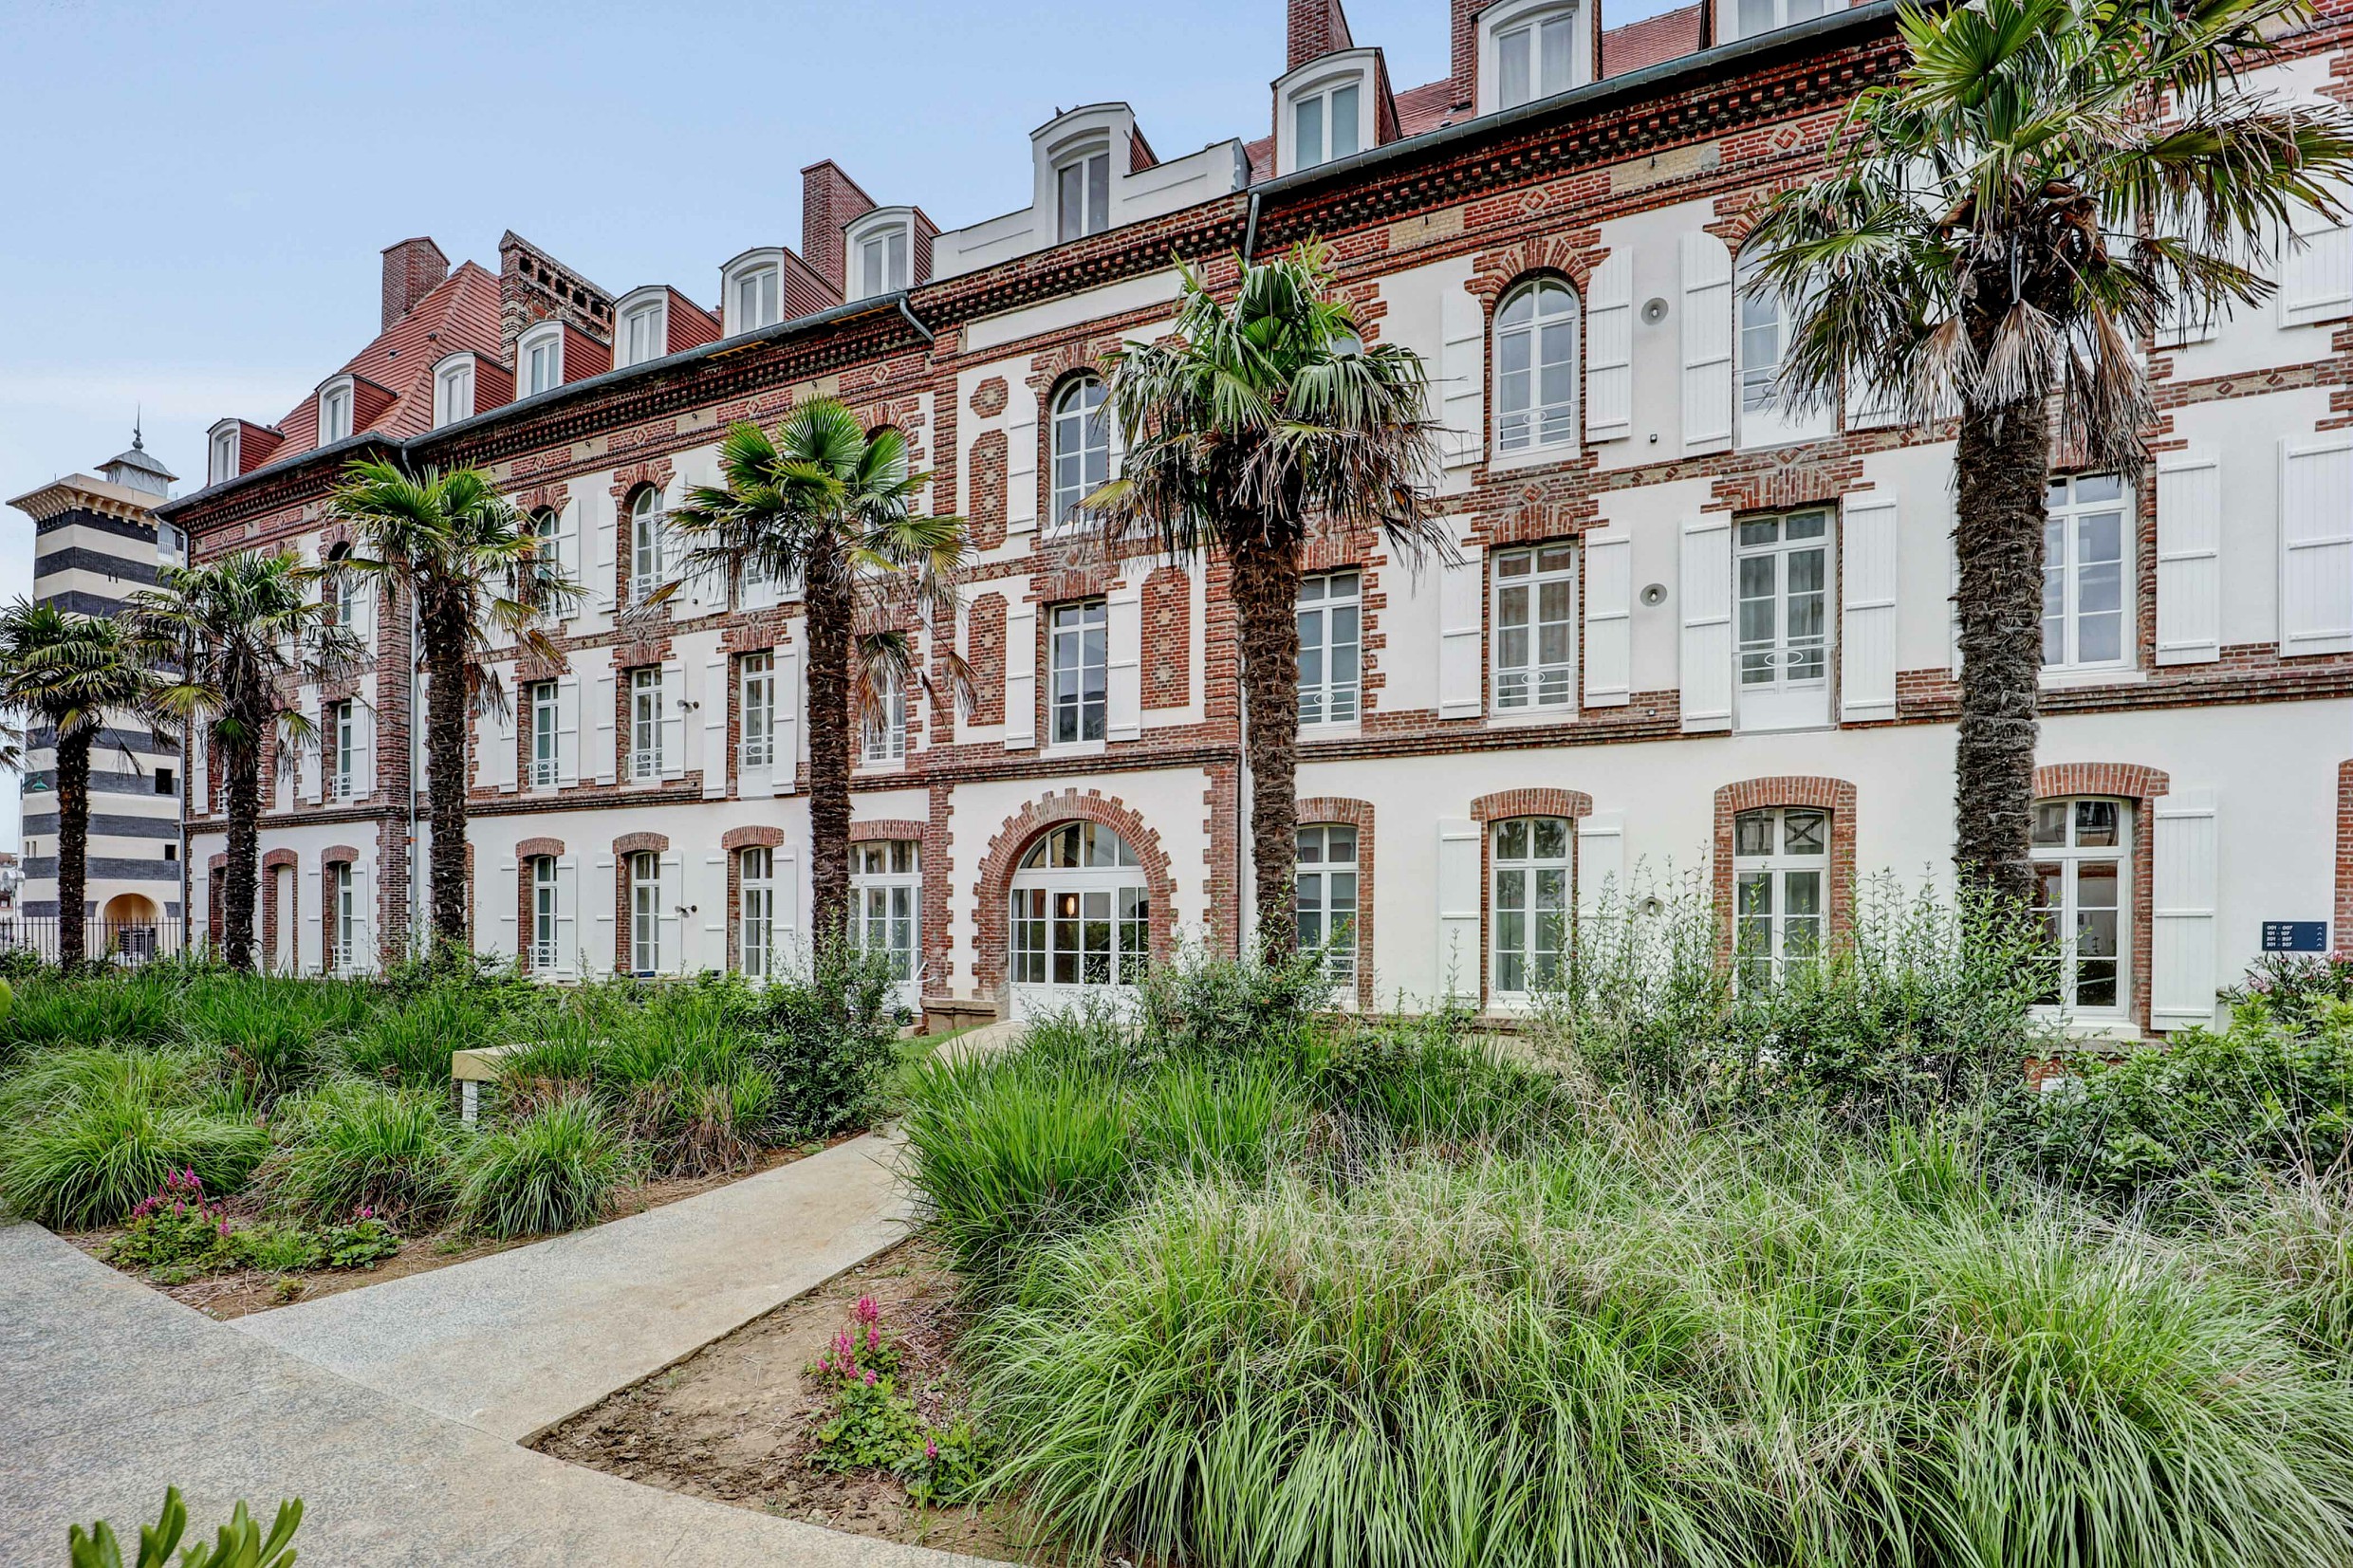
xmin=124 ymin=550 xmax=360 ymax=971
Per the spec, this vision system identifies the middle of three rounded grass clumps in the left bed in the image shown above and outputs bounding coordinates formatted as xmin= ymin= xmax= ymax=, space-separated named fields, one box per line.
xmin=259 ymin=1079 xmax=456 ymax=1225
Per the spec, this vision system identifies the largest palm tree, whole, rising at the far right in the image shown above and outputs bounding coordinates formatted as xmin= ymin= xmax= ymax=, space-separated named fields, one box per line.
xmin=1753 ymin=0 xmax=2353 ymax=903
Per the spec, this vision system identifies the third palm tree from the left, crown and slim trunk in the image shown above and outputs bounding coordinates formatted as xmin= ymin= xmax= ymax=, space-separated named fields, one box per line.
xmin=327 ymin=458 xmax=582 ymax=945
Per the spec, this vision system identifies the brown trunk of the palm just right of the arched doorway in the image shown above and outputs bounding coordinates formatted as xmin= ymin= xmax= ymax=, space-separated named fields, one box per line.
xmin=1229 ymin=526 xmax=1299 ymax=959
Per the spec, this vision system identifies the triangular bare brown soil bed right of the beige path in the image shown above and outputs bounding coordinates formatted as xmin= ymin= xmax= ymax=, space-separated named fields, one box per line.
xmin=534 ymin=1239 xmax=1045 ymax=1561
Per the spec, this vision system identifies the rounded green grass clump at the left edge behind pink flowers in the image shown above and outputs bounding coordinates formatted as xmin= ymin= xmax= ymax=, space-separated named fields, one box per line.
xmin=0 ymin=1046 xmax=270 ymax=1229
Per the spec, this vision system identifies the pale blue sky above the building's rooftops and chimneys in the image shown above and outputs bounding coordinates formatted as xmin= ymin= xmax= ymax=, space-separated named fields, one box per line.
xmin=0 ymin=0 xmax=1671 ymax=846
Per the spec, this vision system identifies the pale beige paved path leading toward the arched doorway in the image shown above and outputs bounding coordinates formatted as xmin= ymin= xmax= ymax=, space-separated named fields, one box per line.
xmin=235 ymin=1135 xmax=906 ymax=1444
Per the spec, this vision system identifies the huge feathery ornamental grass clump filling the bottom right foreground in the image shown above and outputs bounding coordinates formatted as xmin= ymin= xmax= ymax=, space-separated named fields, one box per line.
xmin=962 ymin=1142 xmax=2353 ymax=1568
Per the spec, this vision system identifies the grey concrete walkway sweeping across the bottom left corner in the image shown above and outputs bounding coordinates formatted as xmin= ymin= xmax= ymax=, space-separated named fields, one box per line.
xmin=0 ymin=1222 xmax=981 ymax=1568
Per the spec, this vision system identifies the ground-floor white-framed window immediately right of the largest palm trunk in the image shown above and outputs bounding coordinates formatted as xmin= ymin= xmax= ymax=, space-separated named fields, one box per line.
xmin=2030 ymin=797 xmax=2132 ymax=1018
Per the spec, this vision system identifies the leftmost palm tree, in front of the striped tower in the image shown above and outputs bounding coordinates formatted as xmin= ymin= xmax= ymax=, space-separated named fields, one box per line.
xmin=0 ymin=600 xmax=170 ymax=968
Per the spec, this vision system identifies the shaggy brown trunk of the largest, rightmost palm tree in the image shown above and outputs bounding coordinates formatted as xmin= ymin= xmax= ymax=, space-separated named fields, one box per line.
xmin=1953 ymin=399 xmax=2049 ymax=908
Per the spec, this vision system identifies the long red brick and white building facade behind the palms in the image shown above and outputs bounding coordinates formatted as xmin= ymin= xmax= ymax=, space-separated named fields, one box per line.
xmin=167 ymin=0 xmax=2353 ymax=1032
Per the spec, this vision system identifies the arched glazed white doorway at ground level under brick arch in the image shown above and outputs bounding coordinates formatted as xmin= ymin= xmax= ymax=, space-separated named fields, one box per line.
xmin=1005 ymin=821 xmax=1153 ymax=1018
